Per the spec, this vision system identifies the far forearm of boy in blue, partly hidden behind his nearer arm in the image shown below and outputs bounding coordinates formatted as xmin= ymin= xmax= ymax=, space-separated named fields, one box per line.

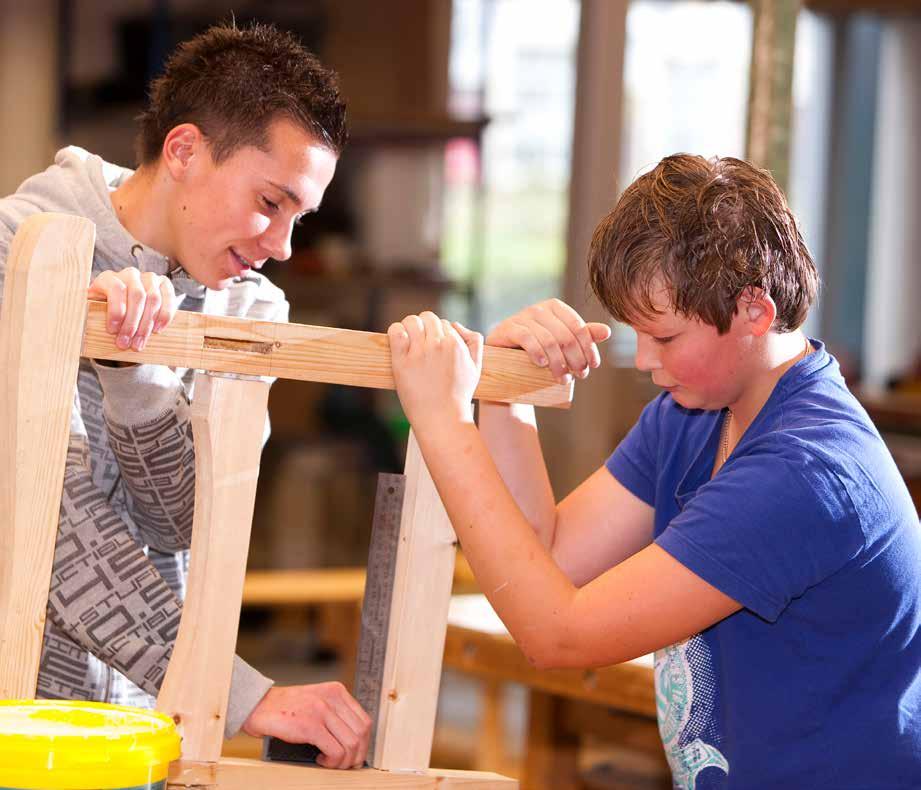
xmin=478 ymin=401 xmax=556 ymax=549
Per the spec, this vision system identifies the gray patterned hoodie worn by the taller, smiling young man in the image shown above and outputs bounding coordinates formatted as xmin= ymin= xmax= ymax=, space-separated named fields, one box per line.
xmin=0 ymin=147 xmax=288 ymax=737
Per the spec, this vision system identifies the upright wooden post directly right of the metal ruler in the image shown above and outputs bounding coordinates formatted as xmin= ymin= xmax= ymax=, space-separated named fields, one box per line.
xmin=370 ymin=432 xmax=456 ymax=771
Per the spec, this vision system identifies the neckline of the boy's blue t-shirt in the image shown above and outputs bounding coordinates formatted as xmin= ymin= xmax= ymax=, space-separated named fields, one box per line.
xmin=666 ymin=338 xmax=834 ymax=507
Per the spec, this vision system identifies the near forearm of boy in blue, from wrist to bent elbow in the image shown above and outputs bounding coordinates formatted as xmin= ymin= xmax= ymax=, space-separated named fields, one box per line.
xmin=416 ymin=423 xmax=576 ymax=666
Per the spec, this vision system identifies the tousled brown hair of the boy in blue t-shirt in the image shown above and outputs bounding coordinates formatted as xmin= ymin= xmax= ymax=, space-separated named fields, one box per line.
xmin=588 ymin=154 xmax=819 ymax=334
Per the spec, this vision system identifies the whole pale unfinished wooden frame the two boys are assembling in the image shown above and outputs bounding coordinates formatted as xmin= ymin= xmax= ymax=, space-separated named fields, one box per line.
xmin=0 ymin=214 xmax=572 ymax=790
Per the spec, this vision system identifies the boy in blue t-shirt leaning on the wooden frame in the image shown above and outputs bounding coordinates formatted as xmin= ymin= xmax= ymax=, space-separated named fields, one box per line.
xmin=389 ymin=154 xmax=921 ymax=790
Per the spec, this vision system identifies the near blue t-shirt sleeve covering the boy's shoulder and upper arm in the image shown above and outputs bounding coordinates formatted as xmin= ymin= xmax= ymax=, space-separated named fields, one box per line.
xmin=656 ymin=446 xmax=864 ymax=622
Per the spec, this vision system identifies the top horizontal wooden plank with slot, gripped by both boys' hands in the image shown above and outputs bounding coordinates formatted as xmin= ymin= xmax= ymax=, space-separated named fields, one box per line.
xmin=83 ymin=301 xmax=573 ymax=408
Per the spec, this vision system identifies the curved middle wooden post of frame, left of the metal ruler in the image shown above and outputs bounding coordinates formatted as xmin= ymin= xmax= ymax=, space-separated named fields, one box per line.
xmin=157 ymin=373 xmax=269 ymax=761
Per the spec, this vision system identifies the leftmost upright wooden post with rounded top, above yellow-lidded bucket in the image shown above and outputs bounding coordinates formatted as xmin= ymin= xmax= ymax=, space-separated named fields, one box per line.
xmin=0 ymin=214 xmax=96 ymax=699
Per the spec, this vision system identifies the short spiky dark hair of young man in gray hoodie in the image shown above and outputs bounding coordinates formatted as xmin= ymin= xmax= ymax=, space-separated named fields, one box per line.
xmin=136 ymin=24 xmax=348 ymax=165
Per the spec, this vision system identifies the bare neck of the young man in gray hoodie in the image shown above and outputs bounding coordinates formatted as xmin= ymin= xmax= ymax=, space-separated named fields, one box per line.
xmin=110 ymin=166 xmax=176 ymax=261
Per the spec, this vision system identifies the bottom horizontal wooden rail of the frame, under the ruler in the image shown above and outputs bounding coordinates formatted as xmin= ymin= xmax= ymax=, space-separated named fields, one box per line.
xmin=168 ymin=758 xmax=518 ymax=790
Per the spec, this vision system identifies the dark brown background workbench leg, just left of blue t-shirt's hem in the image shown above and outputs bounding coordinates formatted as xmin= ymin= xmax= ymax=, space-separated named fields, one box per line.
xmin=521 ymin=690 xmax=579 ymax=790
